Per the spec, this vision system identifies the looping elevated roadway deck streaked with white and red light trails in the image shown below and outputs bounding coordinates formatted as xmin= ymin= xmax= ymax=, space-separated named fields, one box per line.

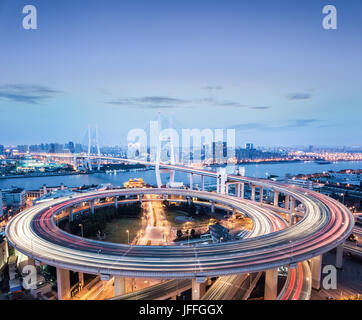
xmin=6 ymin=177 xmax=354 ymax=279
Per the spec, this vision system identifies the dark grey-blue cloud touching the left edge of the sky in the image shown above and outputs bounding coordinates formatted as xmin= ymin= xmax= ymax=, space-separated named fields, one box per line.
xmin=0 ymin=84 xmax=59 ymax=104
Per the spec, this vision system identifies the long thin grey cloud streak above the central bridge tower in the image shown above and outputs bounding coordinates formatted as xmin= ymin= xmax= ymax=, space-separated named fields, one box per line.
xmin=106 ymin=96 xmax=270 ymax=110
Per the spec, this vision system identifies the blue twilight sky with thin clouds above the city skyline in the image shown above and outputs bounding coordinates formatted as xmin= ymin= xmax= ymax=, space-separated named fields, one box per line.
xmin=0 ymin=0 xmax=362 ymax=146
